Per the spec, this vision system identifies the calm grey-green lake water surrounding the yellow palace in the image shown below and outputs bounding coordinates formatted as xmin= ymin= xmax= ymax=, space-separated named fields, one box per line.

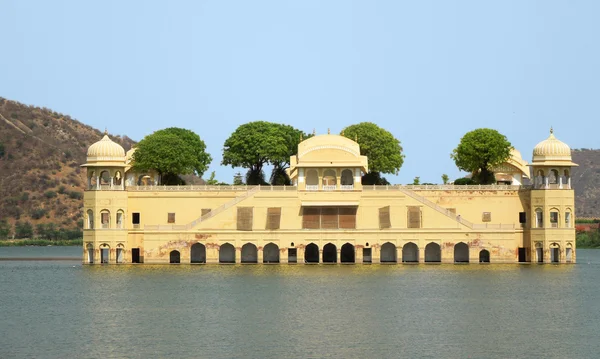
xmin=0 ymin=247 xmax=600 ymax=358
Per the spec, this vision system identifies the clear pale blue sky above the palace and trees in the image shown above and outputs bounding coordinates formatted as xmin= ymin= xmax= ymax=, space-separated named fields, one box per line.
xmin=0 ymin=0 xmax=600 ymax=183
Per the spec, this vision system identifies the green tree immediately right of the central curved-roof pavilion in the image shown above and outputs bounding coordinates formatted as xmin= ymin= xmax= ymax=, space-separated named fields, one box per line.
xmin=342 ymin=122 xmax=404 ymax=184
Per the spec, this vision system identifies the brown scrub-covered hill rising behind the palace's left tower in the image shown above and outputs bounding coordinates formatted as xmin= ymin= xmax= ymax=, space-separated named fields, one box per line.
xmin=0 ymin=98 xmax=134 ymax=239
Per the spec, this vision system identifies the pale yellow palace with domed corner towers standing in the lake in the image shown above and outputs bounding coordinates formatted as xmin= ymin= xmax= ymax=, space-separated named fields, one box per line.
xmin=82 ymin=131 xmax=576 ymax=264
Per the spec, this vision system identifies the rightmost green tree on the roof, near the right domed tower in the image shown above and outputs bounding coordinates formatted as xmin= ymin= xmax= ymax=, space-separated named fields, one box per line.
xmin=450 ymin=128 xmax=512 ymax=184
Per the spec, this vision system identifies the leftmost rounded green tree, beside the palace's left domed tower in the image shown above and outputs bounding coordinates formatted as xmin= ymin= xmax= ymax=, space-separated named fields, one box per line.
xmin=133 ymin=127 xmax=212 ymax=184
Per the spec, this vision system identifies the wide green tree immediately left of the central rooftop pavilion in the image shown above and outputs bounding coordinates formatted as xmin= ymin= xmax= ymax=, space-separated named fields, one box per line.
xmin=221 ymin=121 xmax=302 ymax=185
